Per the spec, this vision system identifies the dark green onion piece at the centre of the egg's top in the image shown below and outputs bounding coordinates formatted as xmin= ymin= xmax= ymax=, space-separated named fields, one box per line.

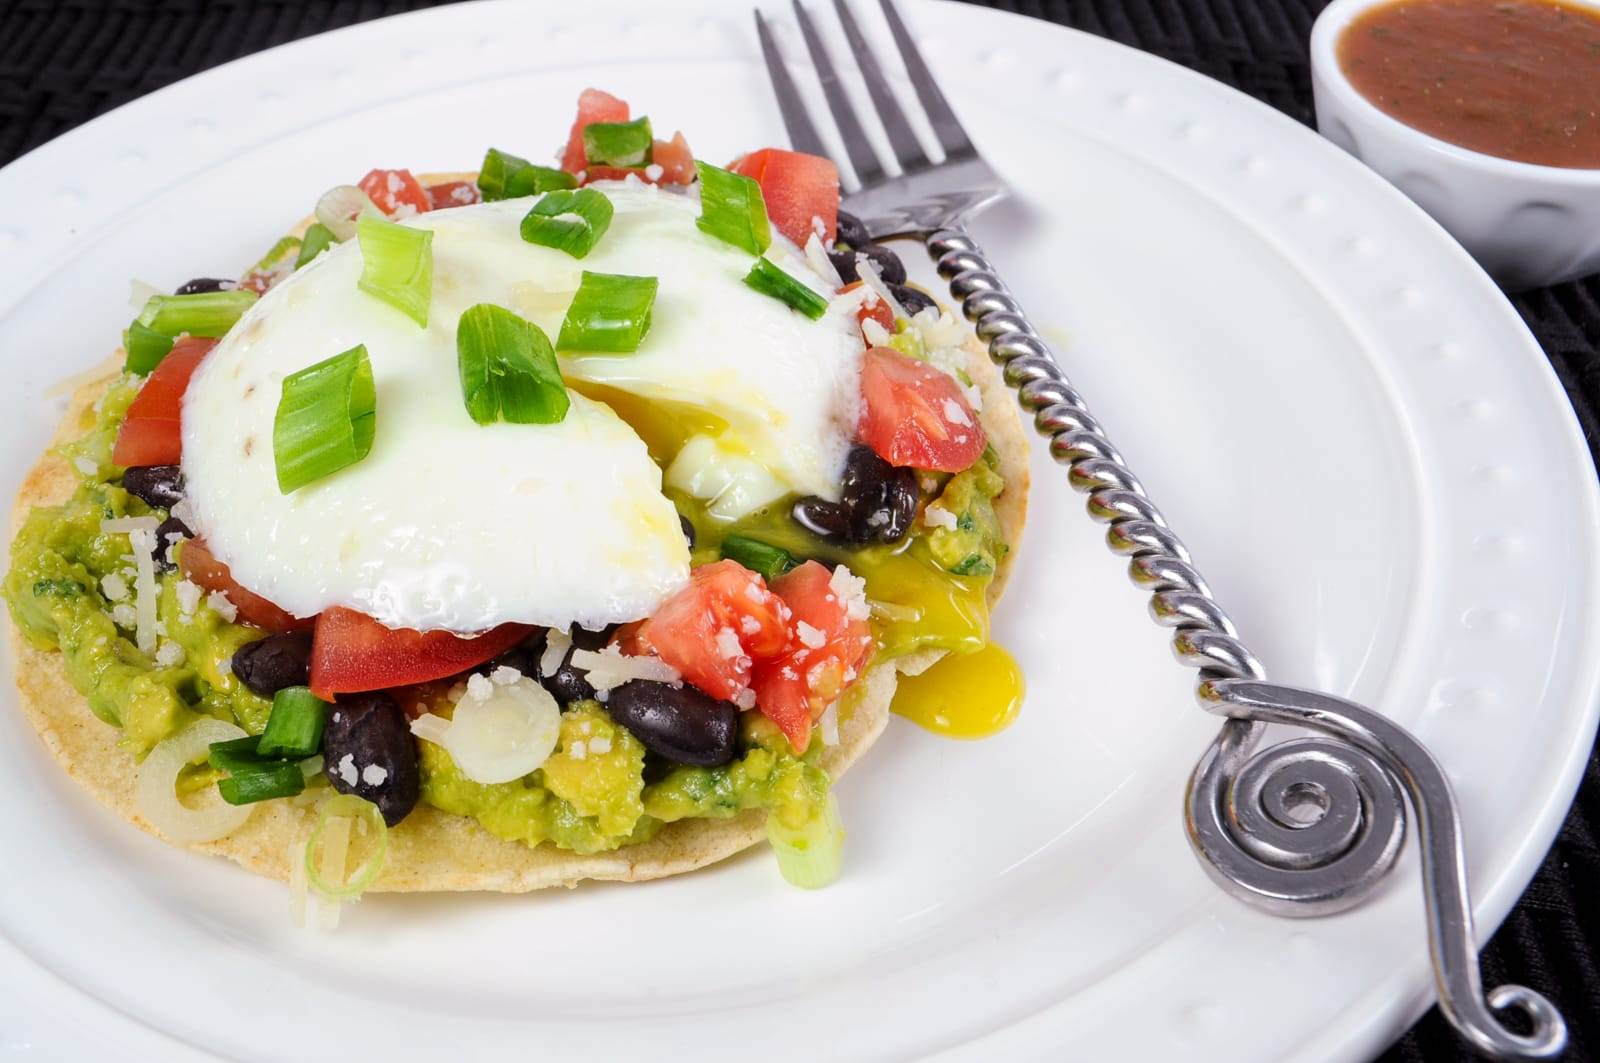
xmin=456 ymin=303 xmax=571 ymax=424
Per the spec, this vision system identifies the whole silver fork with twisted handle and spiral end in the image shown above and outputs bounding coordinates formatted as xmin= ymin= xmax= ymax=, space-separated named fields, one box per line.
xmin=755 ymin=0 xmax=1566 ymax=1060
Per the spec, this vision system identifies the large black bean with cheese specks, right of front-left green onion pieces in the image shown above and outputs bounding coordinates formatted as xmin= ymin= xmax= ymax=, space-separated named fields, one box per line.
xmin=322 ymin=693 xmax=421 ymax=826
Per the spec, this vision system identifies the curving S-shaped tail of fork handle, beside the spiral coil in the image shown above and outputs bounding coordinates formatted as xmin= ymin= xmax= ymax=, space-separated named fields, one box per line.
xmin=1198 ymin=679 xmax=1566 ymax=1060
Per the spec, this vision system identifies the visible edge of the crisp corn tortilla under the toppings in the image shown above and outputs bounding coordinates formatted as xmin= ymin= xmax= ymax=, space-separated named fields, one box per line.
xmin=10 ymin=174 xmax=1027 ymax=893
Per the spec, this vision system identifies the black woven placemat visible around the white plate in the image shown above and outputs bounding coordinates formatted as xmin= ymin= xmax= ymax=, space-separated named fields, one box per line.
xmin=0 ymin=0 xmax=1600 ymax=1061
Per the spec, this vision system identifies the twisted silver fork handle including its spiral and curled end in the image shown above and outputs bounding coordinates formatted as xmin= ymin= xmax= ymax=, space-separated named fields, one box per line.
xmin=923 ymin=227 xmax=1566 ymax=1060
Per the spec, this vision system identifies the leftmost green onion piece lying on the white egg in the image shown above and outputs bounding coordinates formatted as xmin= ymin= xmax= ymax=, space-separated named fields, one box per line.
xmin=272 ymin=346 xmax=378 ymax=495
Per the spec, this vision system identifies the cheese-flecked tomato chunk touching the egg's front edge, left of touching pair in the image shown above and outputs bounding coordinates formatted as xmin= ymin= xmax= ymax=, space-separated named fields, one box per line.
xmin=626 ymin=560 xmax=789 ymax=701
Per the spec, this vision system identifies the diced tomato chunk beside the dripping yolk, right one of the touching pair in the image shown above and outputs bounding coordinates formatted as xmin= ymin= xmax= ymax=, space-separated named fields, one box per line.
xmin=752 ymin=560 xmax=872 ymax=752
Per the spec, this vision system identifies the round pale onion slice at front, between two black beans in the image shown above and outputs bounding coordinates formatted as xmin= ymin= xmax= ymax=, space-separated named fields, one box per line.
xmin=440 ymin=676 xmax=562 ymax=783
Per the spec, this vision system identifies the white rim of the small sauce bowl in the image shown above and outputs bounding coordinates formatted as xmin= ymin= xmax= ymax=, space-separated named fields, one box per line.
xmin=1310 ymin=0 xmax=1600 ymax=191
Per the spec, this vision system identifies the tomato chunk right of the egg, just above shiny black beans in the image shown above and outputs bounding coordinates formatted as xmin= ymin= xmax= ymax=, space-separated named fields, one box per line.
xmin=861 ymin=347 xmax=986 ymax=472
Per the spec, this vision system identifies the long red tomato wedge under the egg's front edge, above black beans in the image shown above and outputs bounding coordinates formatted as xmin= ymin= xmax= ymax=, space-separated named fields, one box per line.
xmin=310 ymin=605 xmax=533 ymax=700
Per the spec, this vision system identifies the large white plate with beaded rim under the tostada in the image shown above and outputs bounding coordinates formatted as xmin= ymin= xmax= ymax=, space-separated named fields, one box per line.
xmin=0 ymin=0 xmax=1600 ymax=1060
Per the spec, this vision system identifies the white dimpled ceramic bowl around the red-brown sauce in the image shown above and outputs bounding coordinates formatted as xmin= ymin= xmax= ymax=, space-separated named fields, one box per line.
xmin=1310 ymin=0 xmax=1600 ymax=288
